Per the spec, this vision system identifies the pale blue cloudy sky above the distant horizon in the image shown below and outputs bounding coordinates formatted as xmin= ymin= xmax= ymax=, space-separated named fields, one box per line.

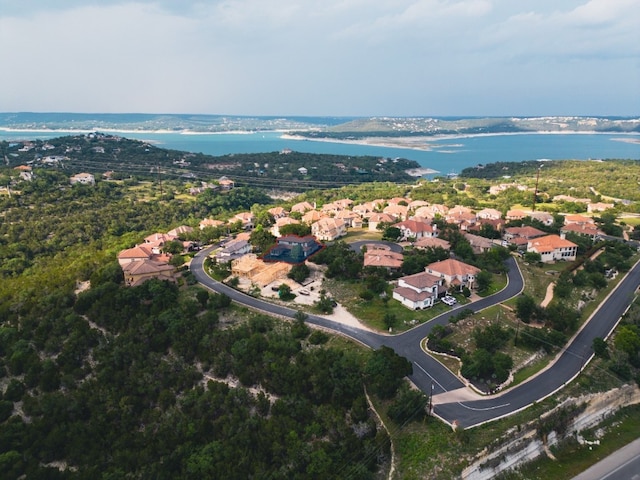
xmin=0 ymin=0 xmax=640 ymax=116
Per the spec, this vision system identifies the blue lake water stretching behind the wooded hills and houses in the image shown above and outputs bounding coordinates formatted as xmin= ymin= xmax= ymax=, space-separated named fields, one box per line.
xmin=0 ymin=131 xmax=640 ymax=173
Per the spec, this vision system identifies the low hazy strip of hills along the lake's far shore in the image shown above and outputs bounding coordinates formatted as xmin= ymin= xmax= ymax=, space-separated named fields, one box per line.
xmin=0 ymin=113 xmax=640 ymax=139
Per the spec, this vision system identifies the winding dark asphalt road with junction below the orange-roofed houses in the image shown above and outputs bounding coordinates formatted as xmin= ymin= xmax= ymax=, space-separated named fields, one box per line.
xmin=191 ymin=248 xmax=640 ymax=428
